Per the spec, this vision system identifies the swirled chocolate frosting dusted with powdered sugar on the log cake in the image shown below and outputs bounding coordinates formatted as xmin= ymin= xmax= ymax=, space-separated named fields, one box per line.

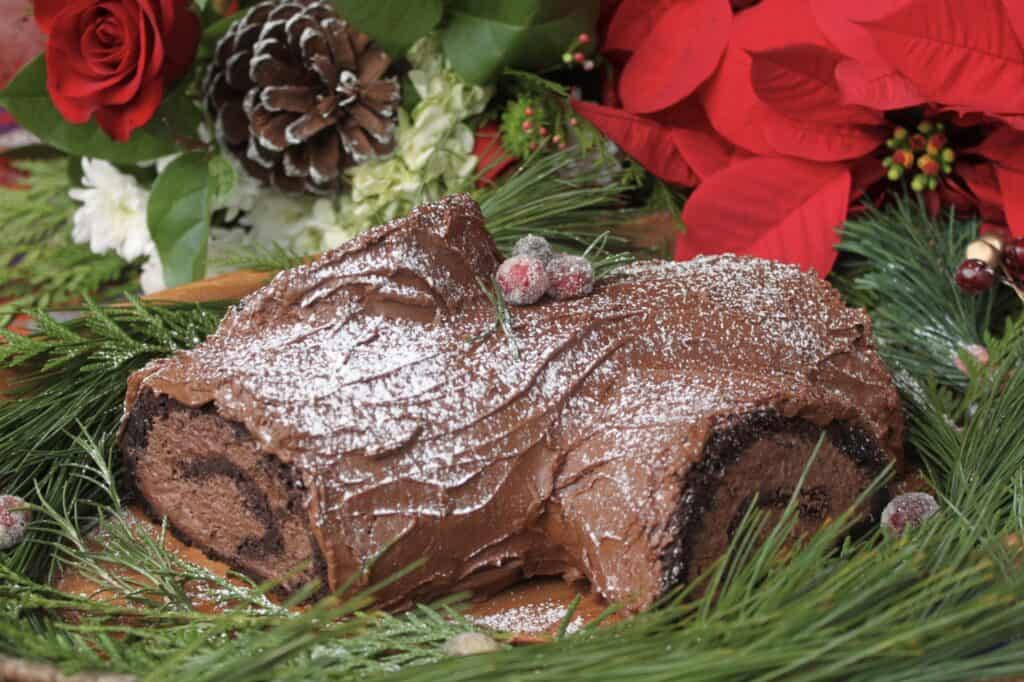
xmin=126 ymin=195 xmax=902 ymax=607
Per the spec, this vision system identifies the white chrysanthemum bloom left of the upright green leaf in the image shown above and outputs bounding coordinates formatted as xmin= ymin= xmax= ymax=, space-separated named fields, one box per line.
xmin=69 ymin=158 xmax=154 ymax=261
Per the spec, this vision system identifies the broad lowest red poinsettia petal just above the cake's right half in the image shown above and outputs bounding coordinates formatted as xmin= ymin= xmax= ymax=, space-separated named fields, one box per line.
xmin=676 ymin=158 xmax=850 ymax=276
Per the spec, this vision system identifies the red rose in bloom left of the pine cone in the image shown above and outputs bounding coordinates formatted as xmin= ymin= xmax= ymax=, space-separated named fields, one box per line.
xmin=35 ymin=0 xmax=200 ymax=141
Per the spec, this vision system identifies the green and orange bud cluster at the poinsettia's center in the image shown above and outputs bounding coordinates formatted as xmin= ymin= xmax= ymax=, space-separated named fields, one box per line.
xmin=882 ymin=120 xmax=956 ymax=191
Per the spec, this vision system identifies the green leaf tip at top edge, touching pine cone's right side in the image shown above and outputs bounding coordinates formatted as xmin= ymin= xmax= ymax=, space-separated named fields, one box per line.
xmin=333 ymin=0 xmax=444 ymax=59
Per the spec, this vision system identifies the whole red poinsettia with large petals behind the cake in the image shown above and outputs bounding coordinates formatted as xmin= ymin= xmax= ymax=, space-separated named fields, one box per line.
xmin=574 ymin=0 xmax=1024 ymax=274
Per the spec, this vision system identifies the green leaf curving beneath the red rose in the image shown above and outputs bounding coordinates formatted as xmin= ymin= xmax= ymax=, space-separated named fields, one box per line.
xmin=0 ymin=55 xmax=177 ymax=164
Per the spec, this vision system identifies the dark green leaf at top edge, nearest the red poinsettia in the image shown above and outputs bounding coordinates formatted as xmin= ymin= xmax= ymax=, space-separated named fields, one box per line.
xmin=441 ymin=0 xmax=600 ymax=83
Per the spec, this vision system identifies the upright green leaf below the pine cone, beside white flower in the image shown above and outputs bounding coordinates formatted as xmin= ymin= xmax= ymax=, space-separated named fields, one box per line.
xmin=146 ymin=152 xmax=210 ymax=287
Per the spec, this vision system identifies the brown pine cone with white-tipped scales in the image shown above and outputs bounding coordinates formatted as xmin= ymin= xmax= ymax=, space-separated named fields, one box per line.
xmin=204 ymin=0 xmax=399 ymax=194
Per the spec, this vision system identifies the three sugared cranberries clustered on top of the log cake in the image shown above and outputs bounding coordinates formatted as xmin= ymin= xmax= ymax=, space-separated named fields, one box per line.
xmin=498 ymin=235 xmax=594 ymax=305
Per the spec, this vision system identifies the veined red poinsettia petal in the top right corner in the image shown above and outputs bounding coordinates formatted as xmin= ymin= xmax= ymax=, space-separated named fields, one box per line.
xmin=863 ymin=0 xmax=1024 ymax=112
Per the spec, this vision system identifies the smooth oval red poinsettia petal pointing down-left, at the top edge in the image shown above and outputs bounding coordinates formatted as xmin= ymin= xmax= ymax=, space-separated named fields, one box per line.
xmin=618 ymin=0 xmax=732 ymax=114
